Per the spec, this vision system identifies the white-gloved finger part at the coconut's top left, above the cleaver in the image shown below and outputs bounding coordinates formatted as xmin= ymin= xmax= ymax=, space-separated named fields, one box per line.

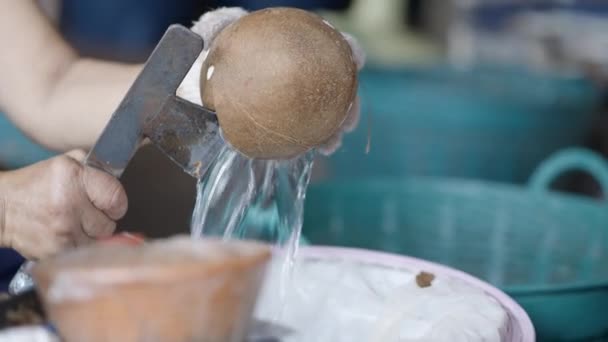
xmin=191 ymin=7 xmax=247 ymax=49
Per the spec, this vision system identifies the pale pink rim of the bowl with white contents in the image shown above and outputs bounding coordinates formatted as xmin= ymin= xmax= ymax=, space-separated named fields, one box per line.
xmin=298 ymin=245 xmax=536 ymax=342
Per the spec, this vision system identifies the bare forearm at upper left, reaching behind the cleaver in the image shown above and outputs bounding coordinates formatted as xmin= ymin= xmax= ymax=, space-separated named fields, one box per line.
xmin=0 ymin=0 xmax=142 ymax=151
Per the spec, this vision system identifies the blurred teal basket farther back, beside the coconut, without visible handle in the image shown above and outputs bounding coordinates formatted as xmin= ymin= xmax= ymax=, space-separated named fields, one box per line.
xmin=319 ymin=67 xmax=600 ymax=183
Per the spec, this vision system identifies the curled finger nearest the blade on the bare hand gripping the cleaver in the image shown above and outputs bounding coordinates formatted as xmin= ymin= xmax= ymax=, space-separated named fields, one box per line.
xmin=82 ymin=167 xmax=128 ymax=220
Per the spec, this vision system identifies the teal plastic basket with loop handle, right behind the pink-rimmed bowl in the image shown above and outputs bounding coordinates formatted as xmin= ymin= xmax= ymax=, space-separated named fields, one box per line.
xmin=303 ymin=149 xmax=608 ymax=341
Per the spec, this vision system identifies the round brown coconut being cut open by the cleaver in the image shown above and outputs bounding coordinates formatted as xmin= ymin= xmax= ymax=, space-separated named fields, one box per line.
xmin=201 ymin=8 xmax=357 ymax=159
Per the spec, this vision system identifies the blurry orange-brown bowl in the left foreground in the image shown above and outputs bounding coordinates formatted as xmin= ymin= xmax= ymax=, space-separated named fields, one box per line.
xmin=34 ymin=237 xmax=270 ymax=342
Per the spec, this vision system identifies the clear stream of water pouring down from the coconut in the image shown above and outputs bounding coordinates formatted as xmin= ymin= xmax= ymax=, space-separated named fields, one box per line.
xmin=191 ymin=146 xmax=314 ymax=319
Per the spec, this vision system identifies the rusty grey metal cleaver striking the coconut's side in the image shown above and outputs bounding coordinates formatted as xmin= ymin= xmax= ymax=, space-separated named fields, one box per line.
xmin=85 ymin=25 xmax=224 ymax=178
